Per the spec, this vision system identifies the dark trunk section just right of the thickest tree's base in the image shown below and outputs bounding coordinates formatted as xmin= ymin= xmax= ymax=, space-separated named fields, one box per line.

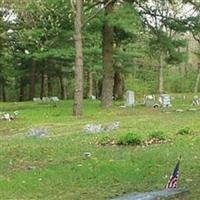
xmin=114 ymin=72 xmax=124 ymax=99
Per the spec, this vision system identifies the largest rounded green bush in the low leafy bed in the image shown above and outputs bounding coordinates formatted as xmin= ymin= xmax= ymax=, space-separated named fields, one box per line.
xmin=117 ymin=132 xmax=142 ymax=145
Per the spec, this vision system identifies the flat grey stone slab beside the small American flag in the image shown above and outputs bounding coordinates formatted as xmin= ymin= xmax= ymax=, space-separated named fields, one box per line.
xmin=112 ymin=188 xmax=189 ymax=200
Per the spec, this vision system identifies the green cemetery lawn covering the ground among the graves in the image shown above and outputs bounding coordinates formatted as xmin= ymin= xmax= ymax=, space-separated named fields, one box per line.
xmin=0 ymin=97 xmax=200 ymax=200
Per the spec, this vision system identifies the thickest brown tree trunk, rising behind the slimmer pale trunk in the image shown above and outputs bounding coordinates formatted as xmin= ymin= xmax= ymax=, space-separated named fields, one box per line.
xmin=101 ymin=0 xmax=114 ymax=108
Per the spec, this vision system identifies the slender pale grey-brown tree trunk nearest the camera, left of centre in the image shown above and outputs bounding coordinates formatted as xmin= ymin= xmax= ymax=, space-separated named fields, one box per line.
xmin=73 ymin=0 xmax=83 ymax=116
